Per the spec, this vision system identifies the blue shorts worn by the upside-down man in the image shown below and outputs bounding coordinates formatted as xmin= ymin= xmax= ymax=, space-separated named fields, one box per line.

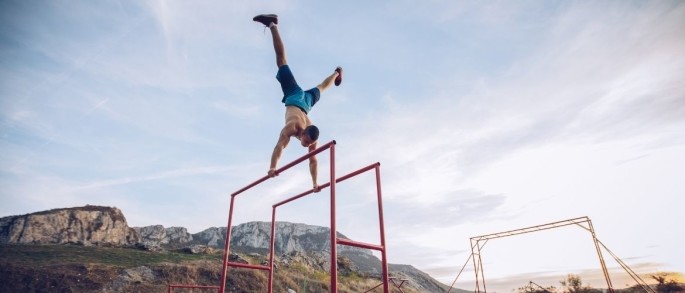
xmin=276 ymin=65 xmax=321 ymax=114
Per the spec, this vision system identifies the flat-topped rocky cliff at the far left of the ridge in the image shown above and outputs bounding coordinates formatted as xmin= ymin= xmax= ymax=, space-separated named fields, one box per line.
xmin=0 ymin=206 xmax=139 ymax=245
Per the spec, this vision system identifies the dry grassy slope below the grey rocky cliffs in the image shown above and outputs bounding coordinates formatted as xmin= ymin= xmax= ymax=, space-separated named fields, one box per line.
xmin=0 ymin=245 xmax=418 ymax=293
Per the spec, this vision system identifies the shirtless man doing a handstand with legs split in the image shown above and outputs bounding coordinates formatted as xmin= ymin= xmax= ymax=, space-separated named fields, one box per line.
xmin=252 ymin=14 xmax=342 ymax=192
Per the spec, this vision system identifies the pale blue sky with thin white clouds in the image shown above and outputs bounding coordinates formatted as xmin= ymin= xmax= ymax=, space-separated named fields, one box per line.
xmin=0 ymin=0 xmax=685 ymax=292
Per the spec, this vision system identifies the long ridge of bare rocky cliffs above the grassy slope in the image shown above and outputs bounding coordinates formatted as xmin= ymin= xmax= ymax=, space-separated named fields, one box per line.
xmin=0 ymin=206 xmax=460 ymax=292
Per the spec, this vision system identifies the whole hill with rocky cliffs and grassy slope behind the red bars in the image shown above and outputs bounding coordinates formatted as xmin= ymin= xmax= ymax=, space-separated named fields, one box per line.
xmin=0 ymin=206 xmax=460 ymax=292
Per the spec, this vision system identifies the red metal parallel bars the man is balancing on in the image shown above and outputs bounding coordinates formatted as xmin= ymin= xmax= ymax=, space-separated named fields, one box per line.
xmin=169 ymin=141 xmax=390 ymax=293
